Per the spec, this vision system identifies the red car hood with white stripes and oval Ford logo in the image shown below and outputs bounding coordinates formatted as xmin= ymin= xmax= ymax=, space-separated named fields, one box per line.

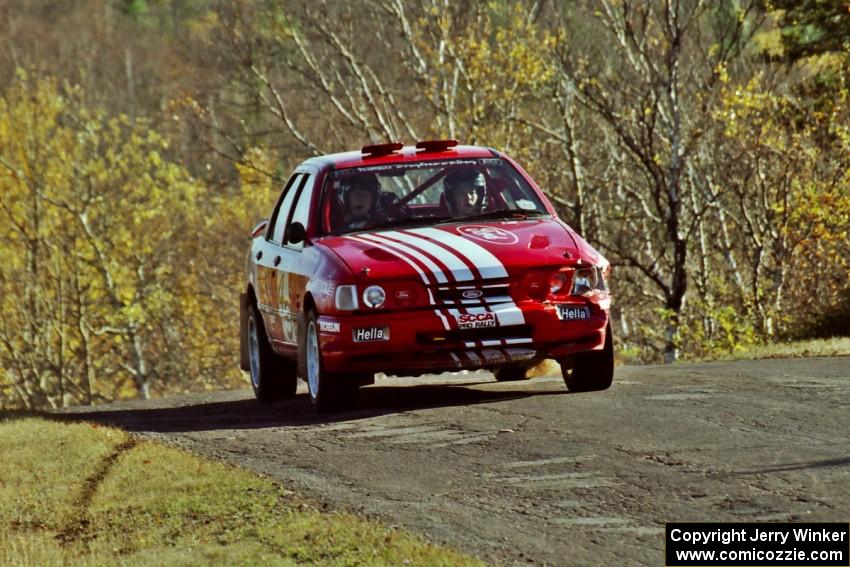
xmin=320 ymin=217 xmax=607 ymax=284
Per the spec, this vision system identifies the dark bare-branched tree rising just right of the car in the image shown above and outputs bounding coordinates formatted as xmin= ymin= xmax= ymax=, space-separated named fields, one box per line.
xmin=548 ymin=0 xmax=757 ymax=362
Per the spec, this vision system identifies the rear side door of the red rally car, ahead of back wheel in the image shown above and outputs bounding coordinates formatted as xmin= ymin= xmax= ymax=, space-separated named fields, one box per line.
xmin=252 ymin=171 xmax=303 ymax=342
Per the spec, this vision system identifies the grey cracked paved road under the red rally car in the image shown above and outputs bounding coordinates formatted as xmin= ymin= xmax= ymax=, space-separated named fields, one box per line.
xmin=63 ymin=358 xmax=850 ymax=566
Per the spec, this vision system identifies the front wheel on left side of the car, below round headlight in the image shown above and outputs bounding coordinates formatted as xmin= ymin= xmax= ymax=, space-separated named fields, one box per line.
xmin=298 ymin=311 xmax=359 ymax=413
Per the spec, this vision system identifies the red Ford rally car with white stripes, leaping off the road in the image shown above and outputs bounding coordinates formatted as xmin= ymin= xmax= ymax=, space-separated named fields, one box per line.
xmin=241 ymin=140 xmax=614 ymax=411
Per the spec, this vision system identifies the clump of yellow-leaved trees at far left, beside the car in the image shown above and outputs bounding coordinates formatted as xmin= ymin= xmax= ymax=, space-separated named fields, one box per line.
xmin=0 ymin=73 xmax=242 ymax=407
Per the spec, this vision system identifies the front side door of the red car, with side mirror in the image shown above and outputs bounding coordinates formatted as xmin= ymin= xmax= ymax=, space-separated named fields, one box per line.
xmin=277 ymin=167 xmax=317 ymax=346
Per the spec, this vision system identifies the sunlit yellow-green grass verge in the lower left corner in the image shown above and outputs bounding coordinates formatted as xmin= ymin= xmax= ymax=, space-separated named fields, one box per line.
xmin=0 ymin=414 xmax=480 ymax=566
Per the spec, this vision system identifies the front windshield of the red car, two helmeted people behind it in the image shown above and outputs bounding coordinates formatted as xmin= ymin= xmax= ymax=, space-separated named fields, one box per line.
xmin=322 ymin=158 xmax=548 ymax=234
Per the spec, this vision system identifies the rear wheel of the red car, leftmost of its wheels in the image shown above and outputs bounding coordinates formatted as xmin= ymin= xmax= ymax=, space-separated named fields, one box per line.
xmin=246 ymin=305 xmax=298 ymax=402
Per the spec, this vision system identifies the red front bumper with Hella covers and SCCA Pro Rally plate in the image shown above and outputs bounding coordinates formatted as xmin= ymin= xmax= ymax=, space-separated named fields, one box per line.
xmin=319 ymin=301 xmax=608 ymax=375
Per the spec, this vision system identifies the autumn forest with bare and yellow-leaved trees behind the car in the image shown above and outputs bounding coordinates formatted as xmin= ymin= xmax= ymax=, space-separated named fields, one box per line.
xmin=0 ymin=0 xmax=850 ymax=408
